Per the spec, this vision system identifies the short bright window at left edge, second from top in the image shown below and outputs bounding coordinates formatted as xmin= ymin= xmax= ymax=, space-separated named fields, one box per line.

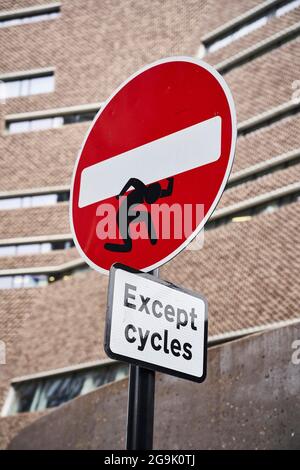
xmin=2 ymin=73 xmax=54 ymax=98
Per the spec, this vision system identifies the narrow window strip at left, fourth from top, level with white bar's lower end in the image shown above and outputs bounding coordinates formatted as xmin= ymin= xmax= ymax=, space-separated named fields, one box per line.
xmin=0 ymin=191 xmax=70 ymax=210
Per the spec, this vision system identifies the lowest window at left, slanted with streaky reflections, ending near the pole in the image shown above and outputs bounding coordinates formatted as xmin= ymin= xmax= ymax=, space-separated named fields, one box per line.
xmin=5 ymin=362 xmax=128 ymax=416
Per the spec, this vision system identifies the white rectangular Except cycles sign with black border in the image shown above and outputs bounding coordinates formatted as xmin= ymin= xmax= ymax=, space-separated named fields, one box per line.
xmin=105 ymin=264 xmax=207 ymax=382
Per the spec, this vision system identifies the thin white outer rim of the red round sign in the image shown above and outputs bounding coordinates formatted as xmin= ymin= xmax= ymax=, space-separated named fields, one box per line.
xmin=69 ymin=56 xmax=237 ymax=275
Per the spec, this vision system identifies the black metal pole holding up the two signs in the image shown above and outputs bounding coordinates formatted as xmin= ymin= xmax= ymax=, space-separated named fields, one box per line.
xmin=126 ymin=269 xmax=159 ymax=450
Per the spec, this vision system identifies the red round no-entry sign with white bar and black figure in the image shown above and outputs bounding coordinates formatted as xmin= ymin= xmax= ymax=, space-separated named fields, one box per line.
xmin=70 ymin=57 xmax=236 ymax=273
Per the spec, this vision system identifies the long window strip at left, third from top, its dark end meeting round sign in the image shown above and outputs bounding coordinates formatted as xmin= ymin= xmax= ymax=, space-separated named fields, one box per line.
xmin=6 ymin=112 xmax=96 ymax=134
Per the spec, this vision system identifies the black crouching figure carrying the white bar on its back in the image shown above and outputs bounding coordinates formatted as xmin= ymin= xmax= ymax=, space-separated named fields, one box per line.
xmin=104 ymin=178 xmax=174 ymax=252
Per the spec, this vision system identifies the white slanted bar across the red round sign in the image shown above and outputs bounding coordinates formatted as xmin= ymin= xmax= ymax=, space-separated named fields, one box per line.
xmin=79 ymin=116 xmax=221 ymax=207
